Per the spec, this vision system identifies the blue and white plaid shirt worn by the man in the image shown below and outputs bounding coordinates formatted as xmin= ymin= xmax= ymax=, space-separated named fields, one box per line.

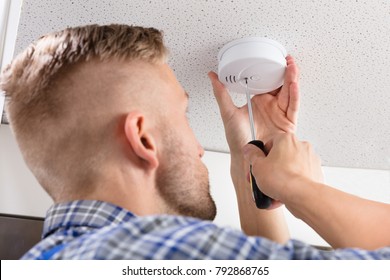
xmin=23 ymin=201 xmax=390 ymax=260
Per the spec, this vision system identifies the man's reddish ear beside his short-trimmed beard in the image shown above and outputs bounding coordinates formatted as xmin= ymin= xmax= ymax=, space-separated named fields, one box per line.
xmin=125 ymin=111 xmax=159 ymax=169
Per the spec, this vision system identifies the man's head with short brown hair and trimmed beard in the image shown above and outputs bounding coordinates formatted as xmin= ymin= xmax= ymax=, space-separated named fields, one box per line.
xmin=1 ymin=25 xmax=215 ymax=219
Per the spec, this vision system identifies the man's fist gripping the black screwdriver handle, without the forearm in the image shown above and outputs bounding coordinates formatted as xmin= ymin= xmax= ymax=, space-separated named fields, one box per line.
xmin=243 ymin=133 xmax=323 ymax=203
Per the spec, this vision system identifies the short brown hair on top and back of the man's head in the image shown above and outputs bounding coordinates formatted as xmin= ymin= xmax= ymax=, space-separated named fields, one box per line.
xmin=0 ymin=24 xmax=167 ymax=199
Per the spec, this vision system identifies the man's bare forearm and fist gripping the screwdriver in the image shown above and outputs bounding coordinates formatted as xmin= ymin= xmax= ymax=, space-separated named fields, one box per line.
xmin=243 ymin=133 xmax=390 ymax=250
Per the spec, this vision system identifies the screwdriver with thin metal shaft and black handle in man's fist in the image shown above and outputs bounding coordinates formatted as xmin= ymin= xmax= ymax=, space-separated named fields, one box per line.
xmin=245 ymin=78 xmax=272 ymax=209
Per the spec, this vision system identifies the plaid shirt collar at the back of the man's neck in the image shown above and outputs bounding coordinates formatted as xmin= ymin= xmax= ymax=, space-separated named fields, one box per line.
xmin=42 ymin=200 xmax=134 ymax=238
